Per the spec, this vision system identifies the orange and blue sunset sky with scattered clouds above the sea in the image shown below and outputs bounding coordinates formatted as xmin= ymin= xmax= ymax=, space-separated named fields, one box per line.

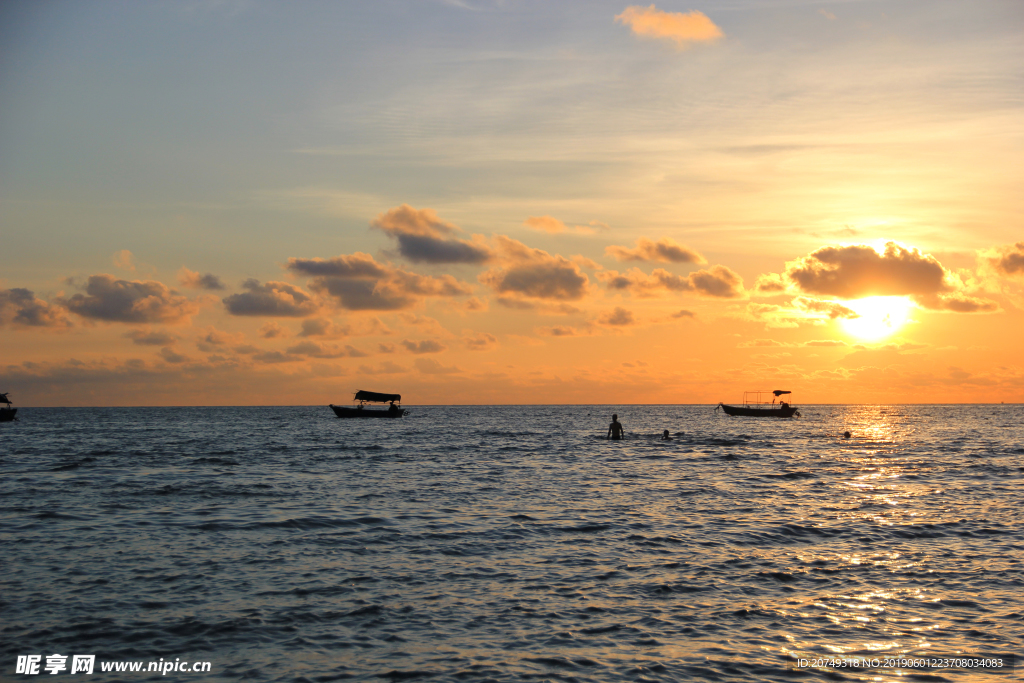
xmin=0 ymin=0 xmax=1024 ymax=407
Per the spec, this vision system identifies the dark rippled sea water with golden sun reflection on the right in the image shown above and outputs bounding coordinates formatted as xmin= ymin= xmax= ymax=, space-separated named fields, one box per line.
xmin=0 ymin=405 xmax=1024 ymax=681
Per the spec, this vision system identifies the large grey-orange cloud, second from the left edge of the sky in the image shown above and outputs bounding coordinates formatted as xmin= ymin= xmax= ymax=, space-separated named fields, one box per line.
xmin=61 ymin=273 xmax=199 ymax=324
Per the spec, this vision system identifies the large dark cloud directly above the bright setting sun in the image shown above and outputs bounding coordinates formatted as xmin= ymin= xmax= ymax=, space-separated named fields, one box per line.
xmin=785 ymin=242 xmax=952 ymax=299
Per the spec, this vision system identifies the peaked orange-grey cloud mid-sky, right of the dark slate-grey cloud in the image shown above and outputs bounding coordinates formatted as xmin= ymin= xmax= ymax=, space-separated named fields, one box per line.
xmin=478 ymin=236 xmax=589 ymax=301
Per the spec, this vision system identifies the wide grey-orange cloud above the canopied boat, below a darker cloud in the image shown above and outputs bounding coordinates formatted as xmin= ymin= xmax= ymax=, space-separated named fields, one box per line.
xmin=288 ymin=252 xmax=472 ymax=310
